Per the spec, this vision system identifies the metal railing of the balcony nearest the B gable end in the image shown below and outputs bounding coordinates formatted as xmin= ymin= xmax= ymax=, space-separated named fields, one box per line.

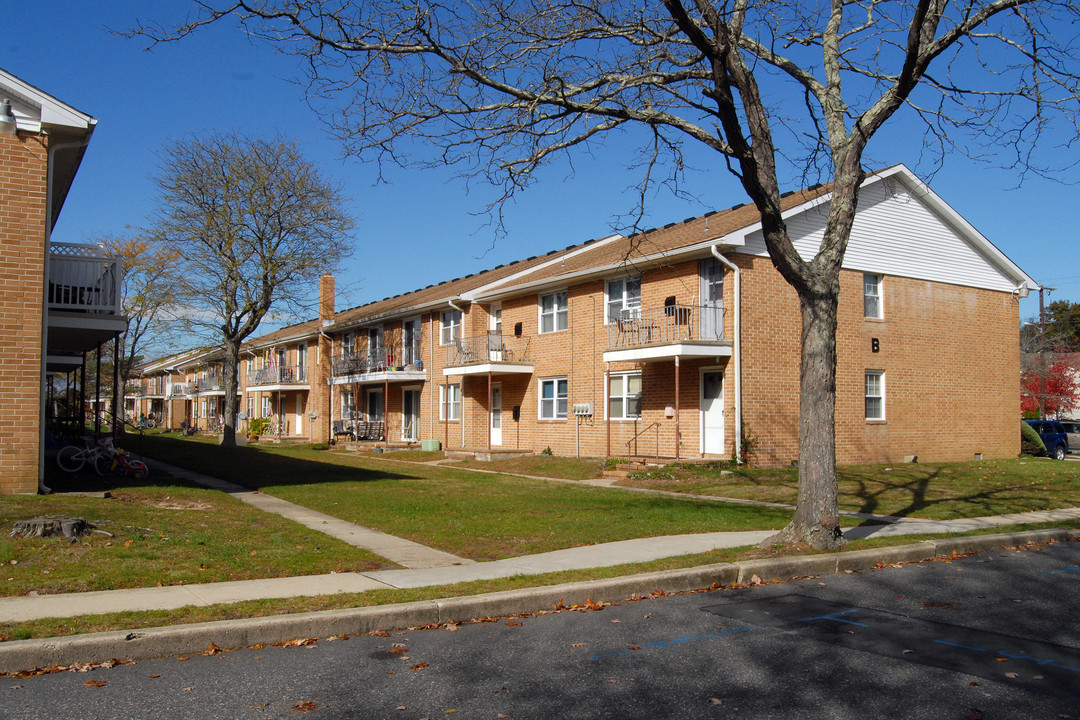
xmin=608 ymin=304 xmax=724 ymax=348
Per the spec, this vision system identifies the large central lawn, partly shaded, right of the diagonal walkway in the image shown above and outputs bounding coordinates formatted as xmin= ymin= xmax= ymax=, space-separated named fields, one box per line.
xmin=135 ymin=437 xmax=789 ymax=560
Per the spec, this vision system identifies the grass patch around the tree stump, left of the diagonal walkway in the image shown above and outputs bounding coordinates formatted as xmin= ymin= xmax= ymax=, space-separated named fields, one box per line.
xmin=0 ymin=462 xmax=395 ymax=596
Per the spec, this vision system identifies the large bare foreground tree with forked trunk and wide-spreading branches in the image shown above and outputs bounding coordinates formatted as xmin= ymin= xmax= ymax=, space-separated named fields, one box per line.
xmin=132 ymin=0 xmax=1078 ymax=547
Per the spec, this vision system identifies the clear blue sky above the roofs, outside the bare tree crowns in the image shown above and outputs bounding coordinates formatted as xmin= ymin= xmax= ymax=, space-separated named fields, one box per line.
xmin=0 ymin=0 xmax=1080 ymax=343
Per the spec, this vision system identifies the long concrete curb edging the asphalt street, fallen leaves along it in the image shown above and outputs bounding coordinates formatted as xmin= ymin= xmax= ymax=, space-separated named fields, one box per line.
xmin=0 ymin=530 xmax=1080 ymax=674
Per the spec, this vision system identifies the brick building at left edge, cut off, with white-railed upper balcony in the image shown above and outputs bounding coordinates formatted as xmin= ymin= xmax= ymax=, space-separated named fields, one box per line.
xmin=0 ymin=70 xmax=126 ymax=493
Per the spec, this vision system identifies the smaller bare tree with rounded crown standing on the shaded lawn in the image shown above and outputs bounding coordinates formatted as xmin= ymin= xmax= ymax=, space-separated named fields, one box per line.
xmin=154 ymin=130 xmax=353 ymax=446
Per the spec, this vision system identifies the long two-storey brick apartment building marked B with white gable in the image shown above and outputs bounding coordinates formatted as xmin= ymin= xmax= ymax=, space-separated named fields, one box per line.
xmin=127 ymin=165 xmax=1036 ymax=465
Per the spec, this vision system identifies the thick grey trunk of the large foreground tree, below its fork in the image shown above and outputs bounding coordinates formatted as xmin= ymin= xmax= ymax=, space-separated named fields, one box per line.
xmin=761 ymin=276 xmax=847 ymax=549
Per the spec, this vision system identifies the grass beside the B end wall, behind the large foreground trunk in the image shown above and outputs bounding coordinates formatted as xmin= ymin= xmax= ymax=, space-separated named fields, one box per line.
xmin=619 ymin=457 xmax=1080 ymax=520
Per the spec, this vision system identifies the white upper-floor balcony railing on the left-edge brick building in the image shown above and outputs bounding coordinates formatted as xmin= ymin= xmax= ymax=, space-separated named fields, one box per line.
xmin=49 ymin=243 xmax=123 ymax=315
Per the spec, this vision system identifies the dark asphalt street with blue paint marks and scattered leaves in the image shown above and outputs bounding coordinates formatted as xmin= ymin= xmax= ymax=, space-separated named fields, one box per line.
xmin=0 ymin=542 xmax=1080 ymax=720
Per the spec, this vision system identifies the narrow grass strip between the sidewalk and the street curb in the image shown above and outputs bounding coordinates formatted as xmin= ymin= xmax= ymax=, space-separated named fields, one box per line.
xmin=0 ymin=522 xmax=1058 ymax=641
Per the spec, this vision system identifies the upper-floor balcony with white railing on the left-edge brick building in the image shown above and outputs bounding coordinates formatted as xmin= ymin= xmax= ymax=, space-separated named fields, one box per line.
xmin=45 ymin=243 xmax=127 ymax=369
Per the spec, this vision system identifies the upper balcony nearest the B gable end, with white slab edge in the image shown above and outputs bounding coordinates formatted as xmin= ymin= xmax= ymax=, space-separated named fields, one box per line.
xmin=604 ymin=303 xmax=731 ymax=363
